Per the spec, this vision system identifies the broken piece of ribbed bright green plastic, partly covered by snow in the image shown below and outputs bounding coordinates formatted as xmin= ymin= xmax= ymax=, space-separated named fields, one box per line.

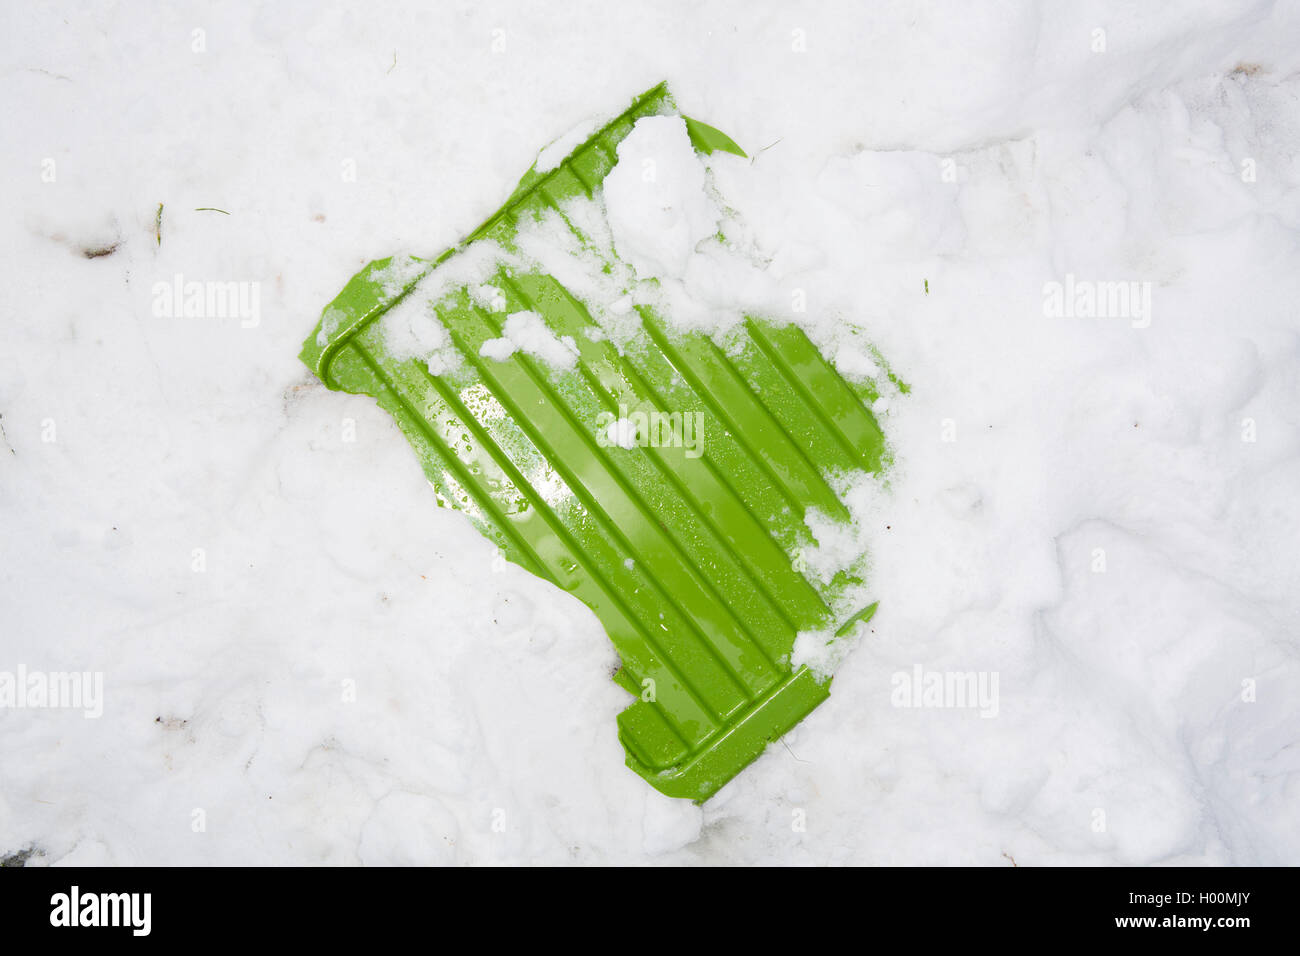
xmin=302 ymin=85 xmax=884 ymax=801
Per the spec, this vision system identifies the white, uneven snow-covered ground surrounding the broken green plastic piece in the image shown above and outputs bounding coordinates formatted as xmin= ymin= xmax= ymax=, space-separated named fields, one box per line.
xmin=0 ymin=0 xmax=1300 ymax=865
